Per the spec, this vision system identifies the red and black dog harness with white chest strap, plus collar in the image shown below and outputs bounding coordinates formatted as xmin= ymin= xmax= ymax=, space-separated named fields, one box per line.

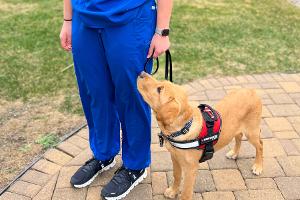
xmin=159 ymin=104 xmax=222 ymax=163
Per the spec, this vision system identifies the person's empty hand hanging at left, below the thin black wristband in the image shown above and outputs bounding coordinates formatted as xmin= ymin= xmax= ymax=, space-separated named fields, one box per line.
xmin=59 ymin=21 xmax=72 ymax=51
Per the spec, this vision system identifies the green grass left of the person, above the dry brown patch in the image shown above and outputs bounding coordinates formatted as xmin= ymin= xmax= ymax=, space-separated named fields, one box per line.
xmin=0 ymin=0 xmax=76 ymax=100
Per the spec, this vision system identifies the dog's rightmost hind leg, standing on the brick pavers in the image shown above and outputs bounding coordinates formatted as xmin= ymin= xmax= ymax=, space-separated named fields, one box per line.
xmin=246 ymin=127 xmax=263 ymax=175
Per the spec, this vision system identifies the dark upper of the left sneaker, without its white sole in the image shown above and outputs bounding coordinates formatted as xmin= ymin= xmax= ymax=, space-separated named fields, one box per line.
xmin=70 ymin=158 xmax=114 ymax=186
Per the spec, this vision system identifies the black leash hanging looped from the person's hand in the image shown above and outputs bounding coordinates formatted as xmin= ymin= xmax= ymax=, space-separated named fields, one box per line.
xmin=144 ymin=50 xmax=173 ymax=82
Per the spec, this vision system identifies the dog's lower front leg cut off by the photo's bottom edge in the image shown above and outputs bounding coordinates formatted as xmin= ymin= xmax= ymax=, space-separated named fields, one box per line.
xmin=180 ymin=163 xmax=198 ymax=200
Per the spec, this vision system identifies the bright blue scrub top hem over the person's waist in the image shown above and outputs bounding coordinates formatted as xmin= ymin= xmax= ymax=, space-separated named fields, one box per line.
xmin=72 ymin=0 xmax=149 ymax=28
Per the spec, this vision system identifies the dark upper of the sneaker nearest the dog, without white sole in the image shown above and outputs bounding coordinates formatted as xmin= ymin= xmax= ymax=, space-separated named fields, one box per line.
xmin=101 ymin=166 xmax=145 ymax=197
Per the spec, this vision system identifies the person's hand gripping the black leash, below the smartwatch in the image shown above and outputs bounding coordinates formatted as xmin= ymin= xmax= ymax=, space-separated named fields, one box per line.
xmin=147 ymin=33 xmax=170 ymax=58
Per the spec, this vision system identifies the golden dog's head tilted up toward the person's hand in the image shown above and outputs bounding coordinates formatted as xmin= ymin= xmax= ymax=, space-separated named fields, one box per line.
xmin=137 ymin=72 xmax=188 ymax=125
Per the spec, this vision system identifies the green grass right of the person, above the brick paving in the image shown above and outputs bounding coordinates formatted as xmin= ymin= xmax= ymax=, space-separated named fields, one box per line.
xmin=166 ymin=0 xmax=300 ymax=82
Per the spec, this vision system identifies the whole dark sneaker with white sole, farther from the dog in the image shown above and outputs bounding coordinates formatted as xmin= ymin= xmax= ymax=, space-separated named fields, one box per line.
xmin=70 ymin=158 xmax=116 ymax=188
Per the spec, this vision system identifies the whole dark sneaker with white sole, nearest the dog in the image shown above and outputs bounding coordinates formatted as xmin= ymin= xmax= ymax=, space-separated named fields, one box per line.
xmin=101 ymin=166 xmax=147 ymax=200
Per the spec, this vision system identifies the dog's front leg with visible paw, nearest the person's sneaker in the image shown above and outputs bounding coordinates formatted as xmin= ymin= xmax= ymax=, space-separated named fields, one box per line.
xmin=164 ymin=155 xmax=182 ymax=199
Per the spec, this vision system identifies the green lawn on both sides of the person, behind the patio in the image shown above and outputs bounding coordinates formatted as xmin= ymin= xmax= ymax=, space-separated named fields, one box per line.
xmin=0 ymin=0 xmax=300 ymax=101
